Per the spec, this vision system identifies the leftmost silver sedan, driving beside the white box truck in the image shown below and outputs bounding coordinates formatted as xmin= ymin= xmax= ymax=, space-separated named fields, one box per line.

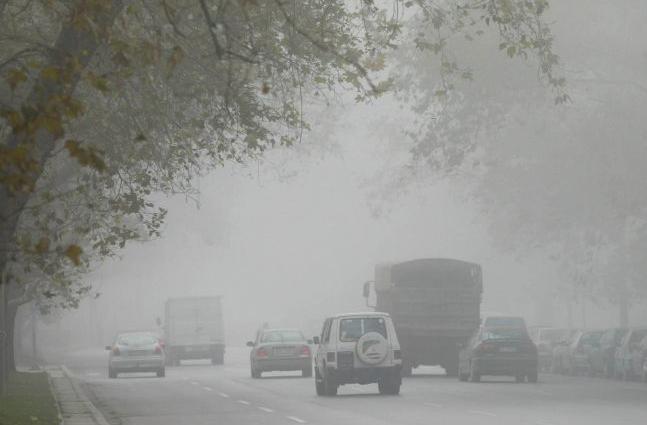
xmin=106 ymin=332 xmax=166 ymax=378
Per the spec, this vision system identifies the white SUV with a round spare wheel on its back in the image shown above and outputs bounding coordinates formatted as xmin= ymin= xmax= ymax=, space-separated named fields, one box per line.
xmin=313 ymin=312 xmax=402 ymax=396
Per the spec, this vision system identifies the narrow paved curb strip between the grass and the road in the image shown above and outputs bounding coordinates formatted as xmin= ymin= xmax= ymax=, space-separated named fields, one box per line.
xmin=45 ymin=366 xmax=109 ymax=425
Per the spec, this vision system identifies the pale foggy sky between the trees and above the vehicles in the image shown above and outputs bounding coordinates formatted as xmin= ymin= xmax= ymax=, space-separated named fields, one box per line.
xmin=13 ymin=1 xmax=647 ymax=358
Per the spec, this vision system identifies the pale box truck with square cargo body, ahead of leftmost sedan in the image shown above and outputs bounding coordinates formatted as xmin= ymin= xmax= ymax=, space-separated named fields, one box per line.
xmin=164 ymin=297 xmax=225 ymax=366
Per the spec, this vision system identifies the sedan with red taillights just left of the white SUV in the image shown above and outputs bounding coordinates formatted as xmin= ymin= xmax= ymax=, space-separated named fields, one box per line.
xmin=247 ymin=329 xmax=312 ymax=378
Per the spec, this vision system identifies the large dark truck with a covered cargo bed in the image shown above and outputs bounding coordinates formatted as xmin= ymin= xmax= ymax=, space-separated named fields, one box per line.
xmin=364 ymin=258 xmax=483 ymax=376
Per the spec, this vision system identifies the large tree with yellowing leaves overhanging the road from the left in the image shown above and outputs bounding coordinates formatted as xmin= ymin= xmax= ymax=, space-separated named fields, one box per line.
xmin=0 ymin=0 xmax=561 ymax=380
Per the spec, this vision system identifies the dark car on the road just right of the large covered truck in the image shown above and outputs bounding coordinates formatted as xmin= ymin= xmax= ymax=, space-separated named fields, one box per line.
xmin=458 ymin=327 xmax=538 ymax=382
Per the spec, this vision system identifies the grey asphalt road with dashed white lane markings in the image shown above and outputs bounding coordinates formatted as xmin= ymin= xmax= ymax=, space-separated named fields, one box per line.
xmin=65 ymin=348 xmax=647 ymax=425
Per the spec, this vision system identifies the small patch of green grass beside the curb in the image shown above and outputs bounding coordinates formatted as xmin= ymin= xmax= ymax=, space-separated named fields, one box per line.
xmin=0 ymin=372 xmax=59 ymax=425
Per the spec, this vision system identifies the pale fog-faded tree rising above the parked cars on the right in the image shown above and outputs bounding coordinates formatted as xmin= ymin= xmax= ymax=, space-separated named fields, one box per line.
xmin=380 ymin=2 xmax=647 ymax=324
